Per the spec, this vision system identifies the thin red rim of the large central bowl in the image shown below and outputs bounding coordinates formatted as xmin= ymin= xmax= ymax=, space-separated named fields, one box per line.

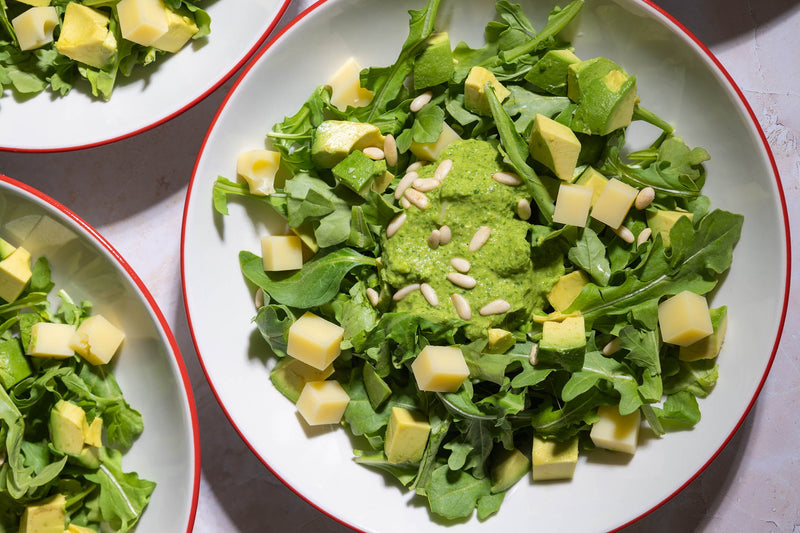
xmin=181 ymin=0 xmax=792 ymax=531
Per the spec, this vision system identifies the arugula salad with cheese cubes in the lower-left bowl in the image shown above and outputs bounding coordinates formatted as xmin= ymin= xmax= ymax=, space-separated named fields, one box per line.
xmin=0 ymin=239 xmax=155 ymax=533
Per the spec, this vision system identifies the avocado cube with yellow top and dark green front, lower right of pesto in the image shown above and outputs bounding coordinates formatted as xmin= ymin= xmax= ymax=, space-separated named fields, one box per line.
xmin=536 ymin=316 xmax=586 ymax=372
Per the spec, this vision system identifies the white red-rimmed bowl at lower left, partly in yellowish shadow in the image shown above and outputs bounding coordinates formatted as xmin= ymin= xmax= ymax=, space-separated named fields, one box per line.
xmin=0 ymin=175 xmax=200 ymax=533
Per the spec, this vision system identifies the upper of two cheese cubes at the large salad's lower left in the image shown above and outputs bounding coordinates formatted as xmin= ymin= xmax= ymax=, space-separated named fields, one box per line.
xmin=286 ymin=311 xmax=344 ymax=370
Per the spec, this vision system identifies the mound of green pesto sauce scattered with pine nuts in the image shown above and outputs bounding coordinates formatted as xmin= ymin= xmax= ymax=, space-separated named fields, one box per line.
xmin=382 ymin=139 xmax=564 ymax=339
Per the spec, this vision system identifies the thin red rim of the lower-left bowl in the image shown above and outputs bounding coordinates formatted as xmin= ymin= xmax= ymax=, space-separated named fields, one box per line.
xmin=0 ymin=174 xmax=200 ymax=533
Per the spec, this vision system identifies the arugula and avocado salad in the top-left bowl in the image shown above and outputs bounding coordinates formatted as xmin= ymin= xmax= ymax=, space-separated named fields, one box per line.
xmin=0 ymin=0 xmax=211 ymax=100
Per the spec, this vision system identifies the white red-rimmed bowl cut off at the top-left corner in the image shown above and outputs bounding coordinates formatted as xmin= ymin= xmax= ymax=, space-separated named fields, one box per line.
xmin=0 ymin=0 xmax=290 ymax=151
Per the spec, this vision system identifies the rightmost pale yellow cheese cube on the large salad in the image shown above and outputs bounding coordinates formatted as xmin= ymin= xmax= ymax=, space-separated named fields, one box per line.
xmin=658 ymin=291 xmax=714 ymax=346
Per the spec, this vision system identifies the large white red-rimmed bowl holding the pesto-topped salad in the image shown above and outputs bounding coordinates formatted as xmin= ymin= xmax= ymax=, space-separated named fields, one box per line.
xmin=182 ymin=0 xmax=790 ymax=533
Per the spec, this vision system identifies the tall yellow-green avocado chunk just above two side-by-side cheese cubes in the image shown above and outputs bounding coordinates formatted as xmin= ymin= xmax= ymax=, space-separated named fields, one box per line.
xmin=528 ymin=114 xmax=581 ymax=182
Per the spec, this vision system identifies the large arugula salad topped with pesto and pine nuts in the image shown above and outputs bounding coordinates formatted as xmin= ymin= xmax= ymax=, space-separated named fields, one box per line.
xmin=213 ymin=0 xmax=743 ymax=520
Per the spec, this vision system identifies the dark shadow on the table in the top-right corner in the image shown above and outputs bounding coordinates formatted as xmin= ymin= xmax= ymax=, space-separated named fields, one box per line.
xmin=652 ymin=0 xmax=800 ymax=46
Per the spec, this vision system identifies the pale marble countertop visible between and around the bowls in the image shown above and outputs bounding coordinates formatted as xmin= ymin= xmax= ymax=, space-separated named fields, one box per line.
xmin=0 ymin=0 xmax=800 ymax=533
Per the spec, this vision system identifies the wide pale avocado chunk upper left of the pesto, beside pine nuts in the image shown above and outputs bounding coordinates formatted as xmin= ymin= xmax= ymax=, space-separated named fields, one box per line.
xmin=311 ymin=120 xmax=383 ymax=168
